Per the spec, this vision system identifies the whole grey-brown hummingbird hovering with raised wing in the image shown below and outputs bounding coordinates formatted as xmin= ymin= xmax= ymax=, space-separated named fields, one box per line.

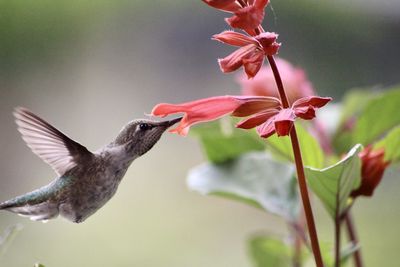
xmin=0 ymin=107 xmax=181 ymax=223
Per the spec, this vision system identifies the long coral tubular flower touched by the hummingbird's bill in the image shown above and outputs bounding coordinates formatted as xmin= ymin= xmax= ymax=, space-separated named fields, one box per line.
xmin=151 ymin=95 xmax=280 ymax=136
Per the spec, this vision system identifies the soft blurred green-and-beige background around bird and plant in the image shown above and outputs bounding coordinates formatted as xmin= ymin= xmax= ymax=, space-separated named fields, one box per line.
xmin=0 ymin=0 xmax=400 ymax=267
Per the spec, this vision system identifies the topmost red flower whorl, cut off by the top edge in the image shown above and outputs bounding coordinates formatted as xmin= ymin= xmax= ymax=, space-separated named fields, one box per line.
xmin=203 ymin=0 xmax=269 ymax=35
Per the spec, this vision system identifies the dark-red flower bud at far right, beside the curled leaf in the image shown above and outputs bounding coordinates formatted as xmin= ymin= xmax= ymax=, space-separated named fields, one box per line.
xmin=351 ymin=146 xmax=390 ymax=198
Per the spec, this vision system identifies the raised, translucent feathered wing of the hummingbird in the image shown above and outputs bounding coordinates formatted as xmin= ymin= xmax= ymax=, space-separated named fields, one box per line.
xmin=14 ymin=107 xmax=93 ymax=176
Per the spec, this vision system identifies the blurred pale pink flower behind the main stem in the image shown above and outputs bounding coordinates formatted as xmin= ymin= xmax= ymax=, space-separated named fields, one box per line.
xmin=237 ymin=58 xmax=314 ymax=103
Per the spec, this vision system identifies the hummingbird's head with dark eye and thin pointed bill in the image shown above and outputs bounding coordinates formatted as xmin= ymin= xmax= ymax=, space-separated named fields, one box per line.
xmin=114 ymin=118 xmax=182 ymax=156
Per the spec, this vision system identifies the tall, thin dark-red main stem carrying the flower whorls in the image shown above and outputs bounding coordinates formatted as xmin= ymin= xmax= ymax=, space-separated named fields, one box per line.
xmin=267 ymin=56 xmax=324 ymax=267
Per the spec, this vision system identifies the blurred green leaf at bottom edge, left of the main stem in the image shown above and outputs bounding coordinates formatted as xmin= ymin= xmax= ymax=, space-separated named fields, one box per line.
xmin=249 ymin=236 xmax=293 ymax=267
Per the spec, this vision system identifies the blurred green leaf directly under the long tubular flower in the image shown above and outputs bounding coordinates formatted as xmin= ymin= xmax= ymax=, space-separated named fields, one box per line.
xmin=191 ymin=117 xmax=266 ymax=163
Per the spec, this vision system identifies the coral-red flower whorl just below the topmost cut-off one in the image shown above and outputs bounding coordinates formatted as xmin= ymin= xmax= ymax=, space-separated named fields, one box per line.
xmin=213 ymin=31 xmax=280 ymax=78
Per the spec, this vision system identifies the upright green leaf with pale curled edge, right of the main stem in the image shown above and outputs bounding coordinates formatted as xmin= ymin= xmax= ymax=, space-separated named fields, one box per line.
xmin=305 ymin=144 xmax=362 ymax=219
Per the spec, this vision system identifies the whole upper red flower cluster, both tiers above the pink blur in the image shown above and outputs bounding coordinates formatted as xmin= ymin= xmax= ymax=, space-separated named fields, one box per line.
xmin=203 ymin=0 xmax=280 ymax=78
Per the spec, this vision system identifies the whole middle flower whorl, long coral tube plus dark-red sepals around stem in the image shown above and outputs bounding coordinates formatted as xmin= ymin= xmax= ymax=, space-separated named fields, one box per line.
xmin=152 ymin=96 xmax=331 ymax=138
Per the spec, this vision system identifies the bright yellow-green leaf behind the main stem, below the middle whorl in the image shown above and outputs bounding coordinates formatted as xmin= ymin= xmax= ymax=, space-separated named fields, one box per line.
xmin=267 ymin=123 xmax=324 ymax=168
